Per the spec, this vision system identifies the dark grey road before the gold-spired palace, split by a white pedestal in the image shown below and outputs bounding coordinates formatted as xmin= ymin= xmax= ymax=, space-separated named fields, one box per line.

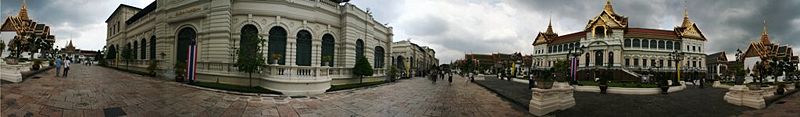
xmin=476 ymin=78 xmax=752 ymax=117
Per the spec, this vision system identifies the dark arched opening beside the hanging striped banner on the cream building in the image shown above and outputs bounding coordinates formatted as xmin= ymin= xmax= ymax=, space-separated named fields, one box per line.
xmin=175 ymin=28 xmax=197 ymax=64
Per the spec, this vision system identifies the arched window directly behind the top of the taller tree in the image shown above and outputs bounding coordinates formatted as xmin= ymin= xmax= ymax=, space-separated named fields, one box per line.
xmin=236 ymin=25 xmax=262 ymax=64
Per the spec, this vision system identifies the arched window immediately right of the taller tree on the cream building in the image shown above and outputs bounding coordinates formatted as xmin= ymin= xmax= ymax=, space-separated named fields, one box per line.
xmin=267 ymin=27 xmax=286 ymax=65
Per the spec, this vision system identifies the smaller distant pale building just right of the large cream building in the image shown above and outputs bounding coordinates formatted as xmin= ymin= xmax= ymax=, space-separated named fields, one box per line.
xmin=392 ymin=40 xmax=439 ymax=77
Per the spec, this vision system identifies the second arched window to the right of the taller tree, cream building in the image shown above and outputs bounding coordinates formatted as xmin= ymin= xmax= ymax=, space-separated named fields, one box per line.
xmin=295 ymin=30 xmax=312 ymax=66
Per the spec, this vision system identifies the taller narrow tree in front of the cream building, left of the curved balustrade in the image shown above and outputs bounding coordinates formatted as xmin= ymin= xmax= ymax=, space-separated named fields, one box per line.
xmin=236 ymin=30 xmax=266 ymax=87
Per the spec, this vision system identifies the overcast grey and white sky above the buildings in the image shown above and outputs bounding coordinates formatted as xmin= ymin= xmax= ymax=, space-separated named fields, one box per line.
xmin=0 ymin=0 xmax=800 ymax=63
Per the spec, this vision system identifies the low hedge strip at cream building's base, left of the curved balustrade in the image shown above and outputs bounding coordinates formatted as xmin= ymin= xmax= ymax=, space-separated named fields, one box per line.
xmin=189 ymin=82 xmax=281 ymax=94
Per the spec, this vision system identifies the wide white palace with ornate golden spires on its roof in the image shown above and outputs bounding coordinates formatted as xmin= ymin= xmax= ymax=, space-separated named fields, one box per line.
xmin=532 ymin=1 xmax=706 ymax=80
